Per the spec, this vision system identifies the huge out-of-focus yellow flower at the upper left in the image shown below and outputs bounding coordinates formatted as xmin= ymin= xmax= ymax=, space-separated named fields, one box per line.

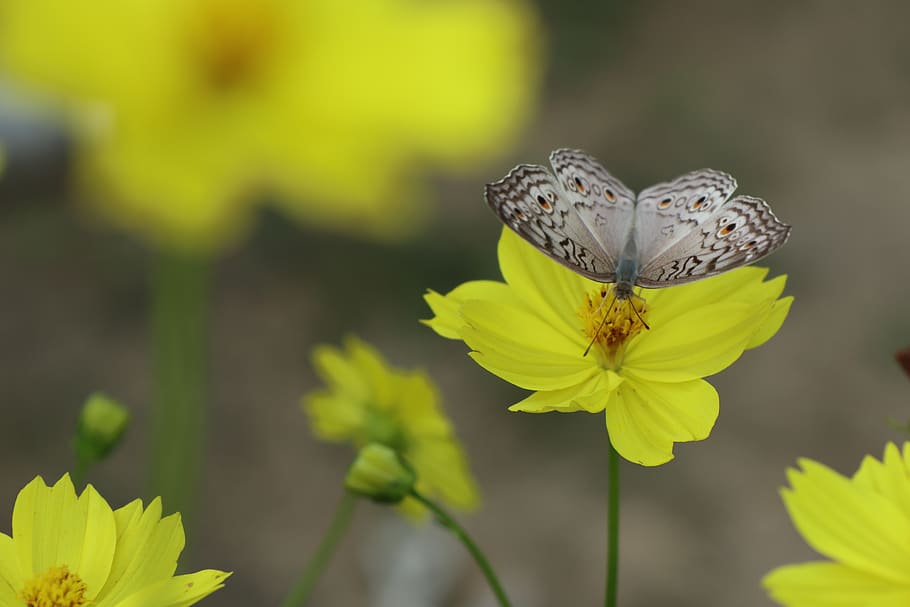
xmin=0 ymin=0 xmax=539 ymax=249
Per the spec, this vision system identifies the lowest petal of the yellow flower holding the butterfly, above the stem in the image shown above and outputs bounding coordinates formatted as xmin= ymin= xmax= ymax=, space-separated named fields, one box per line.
xmin=607 ymin=374 xmax=720 ymax=466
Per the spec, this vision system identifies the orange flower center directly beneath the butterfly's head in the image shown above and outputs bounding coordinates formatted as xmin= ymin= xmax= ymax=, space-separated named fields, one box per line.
xmin=578 ymin=285 xmax=648 ymax=370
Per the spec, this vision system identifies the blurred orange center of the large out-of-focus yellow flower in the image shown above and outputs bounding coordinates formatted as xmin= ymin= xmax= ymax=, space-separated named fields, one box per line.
xmin=190 ymin=0 xmax=280 ymax=92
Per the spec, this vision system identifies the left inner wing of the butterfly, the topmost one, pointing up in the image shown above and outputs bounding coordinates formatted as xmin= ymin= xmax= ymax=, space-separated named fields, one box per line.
xmin=550 ymin=149 xmax=635 ymax=264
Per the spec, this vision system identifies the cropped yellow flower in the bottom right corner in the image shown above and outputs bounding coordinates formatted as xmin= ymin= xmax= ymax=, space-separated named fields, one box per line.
xmin=762 ymin=443 xmax=910 ymax=607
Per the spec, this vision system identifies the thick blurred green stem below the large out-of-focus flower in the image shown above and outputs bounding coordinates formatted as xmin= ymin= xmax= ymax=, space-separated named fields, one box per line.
xmin=150 ymin=251 xmax=210 ymax=527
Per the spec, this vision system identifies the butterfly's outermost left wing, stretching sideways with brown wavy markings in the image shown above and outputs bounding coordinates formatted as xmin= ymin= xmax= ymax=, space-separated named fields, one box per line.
xmin=484 ymin=164 xmax=614 ymax=282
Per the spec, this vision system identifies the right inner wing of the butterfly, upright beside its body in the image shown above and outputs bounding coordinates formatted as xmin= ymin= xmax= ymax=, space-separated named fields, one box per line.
xmin=635 ymin=169 xmax=736 ymax=265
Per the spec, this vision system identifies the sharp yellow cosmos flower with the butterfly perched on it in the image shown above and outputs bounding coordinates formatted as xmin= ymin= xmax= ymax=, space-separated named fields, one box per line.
xmin=424 ymin=228 xmax=792 ymax=466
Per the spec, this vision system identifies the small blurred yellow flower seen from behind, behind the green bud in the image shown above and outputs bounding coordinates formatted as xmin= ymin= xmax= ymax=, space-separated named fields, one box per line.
xmin=303 ymin=338 xmax=478 ymax=515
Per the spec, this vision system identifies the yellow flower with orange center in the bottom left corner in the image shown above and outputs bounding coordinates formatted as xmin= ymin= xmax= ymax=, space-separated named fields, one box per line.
xmin=0 ymin=475 xmax=230 ymax=607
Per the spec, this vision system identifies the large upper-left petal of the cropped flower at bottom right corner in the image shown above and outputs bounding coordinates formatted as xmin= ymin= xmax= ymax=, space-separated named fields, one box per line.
xmin=782 ymin=459 xmax=910 ymax=584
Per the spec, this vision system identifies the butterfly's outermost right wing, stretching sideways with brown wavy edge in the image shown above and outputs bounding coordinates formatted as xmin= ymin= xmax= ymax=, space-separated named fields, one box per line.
xmin=637 ymin=196 xmax=790 ymax=288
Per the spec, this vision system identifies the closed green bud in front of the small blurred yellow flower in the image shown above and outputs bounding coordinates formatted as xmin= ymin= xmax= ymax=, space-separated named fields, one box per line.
xmin=344 ymin=443 xmax=417 ymax=504
